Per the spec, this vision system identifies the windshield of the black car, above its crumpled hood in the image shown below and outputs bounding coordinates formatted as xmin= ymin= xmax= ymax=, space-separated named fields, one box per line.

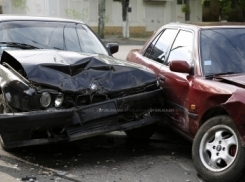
xmin=0 ymin=21 xmax=108 ymax=55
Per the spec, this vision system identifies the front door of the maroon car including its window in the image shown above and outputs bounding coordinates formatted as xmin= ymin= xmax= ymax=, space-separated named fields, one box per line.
xmin=159 ymin=30 xmax=194 ymax=135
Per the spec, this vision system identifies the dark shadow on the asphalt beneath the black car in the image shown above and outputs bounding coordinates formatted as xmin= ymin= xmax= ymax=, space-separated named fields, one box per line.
xmin=12 ymin=124 xmax=191 ymax=170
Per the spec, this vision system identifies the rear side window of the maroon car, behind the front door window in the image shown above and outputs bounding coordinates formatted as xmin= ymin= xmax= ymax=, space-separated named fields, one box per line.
xmin=147 ymin=29 xmax=178 ymax=63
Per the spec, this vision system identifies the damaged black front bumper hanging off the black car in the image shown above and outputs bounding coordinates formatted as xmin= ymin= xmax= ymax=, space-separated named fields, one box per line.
xmin=0 ymin=89 xmax=162 ymax=149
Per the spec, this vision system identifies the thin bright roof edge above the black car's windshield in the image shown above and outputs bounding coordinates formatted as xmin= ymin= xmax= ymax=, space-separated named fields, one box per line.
xmin=0 ymin=15 xmax=83 ymax=23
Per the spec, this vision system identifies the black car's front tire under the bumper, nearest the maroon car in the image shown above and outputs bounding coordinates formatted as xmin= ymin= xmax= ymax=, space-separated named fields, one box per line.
xmin=125 ymin=124 xmax=156 ymax=141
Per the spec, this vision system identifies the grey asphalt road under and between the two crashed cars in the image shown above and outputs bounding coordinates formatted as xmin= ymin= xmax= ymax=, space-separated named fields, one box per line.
xmin=0 ymin=46 xmax=243 ymax=182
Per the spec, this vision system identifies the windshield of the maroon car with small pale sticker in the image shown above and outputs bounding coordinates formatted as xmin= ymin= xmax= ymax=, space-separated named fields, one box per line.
xmin=200 ymin=28 xmax=245 ymax=76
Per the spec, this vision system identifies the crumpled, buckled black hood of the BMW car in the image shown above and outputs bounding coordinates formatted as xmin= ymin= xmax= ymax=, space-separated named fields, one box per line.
xmin=1 ymin=50 xmax=156 ymax=93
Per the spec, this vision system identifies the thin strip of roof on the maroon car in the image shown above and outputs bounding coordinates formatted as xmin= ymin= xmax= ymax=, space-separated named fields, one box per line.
xmin=165 ymin=22 xmax=245 ymax=29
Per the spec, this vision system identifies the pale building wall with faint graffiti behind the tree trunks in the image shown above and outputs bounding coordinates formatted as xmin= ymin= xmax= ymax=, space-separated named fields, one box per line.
xmin=2 ymin=0 xmax=202 ymax=35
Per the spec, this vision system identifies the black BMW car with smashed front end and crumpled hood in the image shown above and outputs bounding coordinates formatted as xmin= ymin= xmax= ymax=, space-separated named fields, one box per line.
xmin=0 ymin=16 xmax=162 ymax=150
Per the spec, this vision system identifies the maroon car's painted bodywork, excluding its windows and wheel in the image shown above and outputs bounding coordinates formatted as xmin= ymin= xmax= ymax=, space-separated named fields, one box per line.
xmin=127 ymin=23 xmax=245 ymax=146
